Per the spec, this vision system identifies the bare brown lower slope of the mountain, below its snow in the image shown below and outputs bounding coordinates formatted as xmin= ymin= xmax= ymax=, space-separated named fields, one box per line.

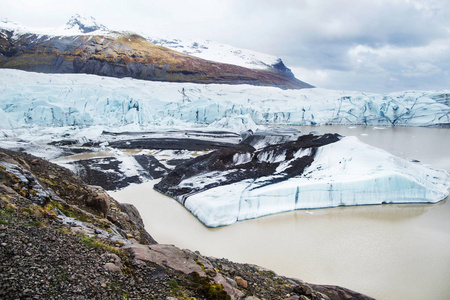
xmin=0 ymin=30 xmax=312 ymax=89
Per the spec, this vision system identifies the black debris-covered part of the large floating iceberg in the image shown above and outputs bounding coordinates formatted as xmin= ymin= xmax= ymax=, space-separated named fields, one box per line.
xmin=154 ymin=134 xmax=340 ymax=204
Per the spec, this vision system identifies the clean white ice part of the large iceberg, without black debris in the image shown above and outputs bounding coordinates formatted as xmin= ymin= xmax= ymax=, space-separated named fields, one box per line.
xmin=184 ymin=137 xmax=450 ymax=227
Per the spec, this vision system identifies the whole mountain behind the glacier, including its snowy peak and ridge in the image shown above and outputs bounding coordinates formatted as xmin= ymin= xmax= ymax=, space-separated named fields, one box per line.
xmin=0 ymin=15 xmax=312 ymax=89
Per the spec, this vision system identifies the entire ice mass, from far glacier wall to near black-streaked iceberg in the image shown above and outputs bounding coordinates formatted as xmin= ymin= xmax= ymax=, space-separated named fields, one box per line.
xmin=0 ymin=69 xmax=450 ymax=227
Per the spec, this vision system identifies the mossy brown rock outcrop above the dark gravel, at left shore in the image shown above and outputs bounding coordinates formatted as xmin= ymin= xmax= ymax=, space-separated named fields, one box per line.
xmin=0 ymin=148 xmax=156 ymax=244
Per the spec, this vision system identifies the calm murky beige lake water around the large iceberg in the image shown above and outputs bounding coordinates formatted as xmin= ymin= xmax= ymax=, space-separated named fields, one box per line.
xmin=111 ymin=126 xmax=450 ymax=300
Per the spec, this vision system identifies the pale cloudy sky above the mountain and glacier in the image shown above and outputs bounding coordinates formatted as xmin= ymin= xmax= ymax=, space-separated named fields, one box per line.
xmin=0 ymin=0 xmax=450 ymax=92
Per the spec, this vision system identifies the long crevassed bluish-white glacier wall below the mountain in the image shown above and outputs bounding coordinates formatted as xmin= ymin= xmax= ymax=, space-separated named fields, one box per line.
xmin=0 ymin=69 xmax=450 ymax=130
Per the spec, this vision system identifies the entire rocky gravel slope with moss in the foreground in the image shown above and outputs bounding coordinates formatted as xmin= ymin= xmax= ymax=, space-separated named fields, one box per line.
xmin=0 ymin=149 xmax=371 ymax=300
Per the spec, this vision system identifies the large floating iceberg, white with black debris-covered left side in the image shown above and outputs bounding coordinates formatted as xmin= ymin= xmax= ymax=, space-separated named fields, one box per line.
xmin=155 ymin=135 xmax=450 ymax=227
